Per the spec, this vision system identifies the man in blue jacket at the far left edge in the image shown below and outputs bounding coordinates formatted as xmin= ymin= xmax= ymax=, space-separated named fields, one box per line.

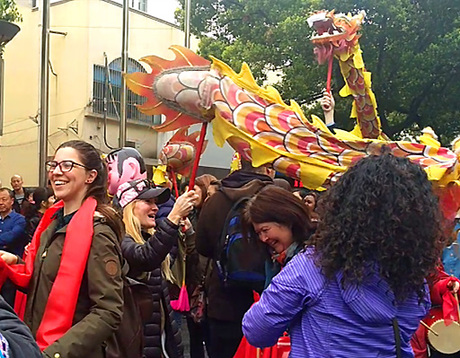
xmin=0 ymin=188 xmax=26 ymax=306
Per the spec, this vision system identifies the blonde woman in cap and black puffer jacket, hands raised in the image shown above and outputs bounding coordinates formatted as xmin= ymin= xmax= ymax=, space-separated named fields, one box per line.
xmin=116 ymin=180 xmax=198 ymax=358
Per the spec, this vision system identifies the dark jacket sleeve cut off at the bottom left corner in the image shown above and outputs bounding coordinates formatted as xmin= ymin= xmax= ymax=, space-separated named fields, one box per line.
xmin=0 ymin=296 xmax=42 ymax=358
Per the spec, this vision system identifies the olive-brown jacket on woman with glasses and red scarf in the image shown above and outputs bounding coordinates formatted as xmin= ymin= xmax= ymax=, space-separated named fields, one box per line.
xmin=24 ymin=216 xmax=123 ymax=358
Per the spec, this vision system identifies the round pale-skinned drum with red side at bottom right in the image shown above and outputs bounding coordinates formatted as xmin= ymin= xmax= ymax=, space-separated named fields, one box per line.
xmin=423 ymin=308 xmax=460 ymax=354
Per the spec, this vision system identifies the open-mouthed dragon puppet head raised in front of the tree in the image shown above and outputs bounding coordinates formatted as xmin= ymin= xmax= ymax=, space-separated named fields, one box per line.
xmin=307 ymin=10 xmax=365 ymax=63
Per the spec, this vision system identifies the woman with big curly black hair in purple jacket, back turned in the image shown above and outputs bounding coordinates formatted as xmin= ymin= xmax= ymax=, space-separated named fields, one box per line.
xmin=243 ymin=154 xmax=442 ymax=358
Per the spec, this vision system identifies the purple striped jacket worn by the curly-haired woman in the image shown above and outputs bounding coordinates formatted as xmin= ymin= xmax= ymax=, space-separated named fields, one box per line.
xmin=243 ymin=248 xmax=430 ymax=358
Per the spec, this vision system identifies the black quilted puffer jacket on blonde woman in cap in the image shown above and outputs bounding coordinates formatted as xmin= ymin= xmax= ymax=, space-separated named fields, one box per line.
xmin=121 ymin=219 xmax=183 ymax=358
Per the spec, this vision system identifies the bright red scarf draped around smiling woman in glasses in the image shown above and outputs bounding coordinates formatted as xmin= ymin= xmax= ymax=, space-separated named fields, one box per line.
xmin=0 ymin=198 xmax=97 ymax=351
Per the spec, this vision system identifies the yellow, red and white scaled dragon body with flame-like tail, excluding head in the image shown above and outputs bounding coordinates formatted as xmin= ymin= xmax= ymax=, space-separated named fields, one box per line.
xmin=126 ymin=17 xmax=459 ymax=189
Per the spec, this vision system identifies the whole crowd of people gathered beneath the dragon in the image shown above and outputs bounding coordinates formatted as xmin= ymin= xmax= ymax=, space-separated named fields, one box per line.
xmin=0 ymin=135 xmax=460 ymax=358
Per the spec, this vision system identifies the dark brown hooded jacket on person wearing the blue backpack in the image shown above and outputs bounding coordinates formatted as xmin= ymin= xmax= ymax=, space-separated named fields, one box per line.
xmin=196 ymin=170 xmax=273 ymax=322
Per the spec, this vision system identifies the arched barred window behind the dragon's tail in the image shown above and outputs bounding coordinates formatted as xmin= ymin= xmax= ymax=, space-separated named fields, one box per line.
xmin=93 ymin=58 xmax=161 ymax=125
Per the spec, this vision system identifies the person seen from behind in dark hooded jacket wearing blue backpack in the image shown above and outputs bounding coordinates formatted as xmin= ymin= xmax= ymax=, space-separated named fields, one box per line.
xmin=196 ymin=160 xmax=273 ymax=358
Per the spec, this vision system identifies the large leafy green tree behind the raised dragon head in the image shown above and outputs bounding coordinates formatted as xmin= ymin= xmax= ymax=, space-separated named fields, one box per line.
xmin=179 ymin=0 xmax=460 ymax=144
